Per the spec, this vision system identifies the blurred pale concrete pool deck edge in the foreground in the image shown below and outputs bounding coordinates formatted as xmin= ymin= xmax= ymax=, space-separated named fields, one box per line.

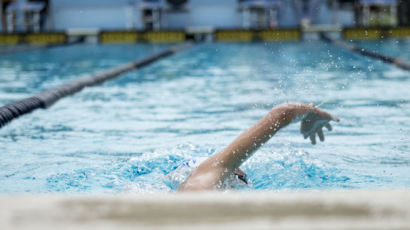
xmin=0 ymin=190 xmax=410 ymax=230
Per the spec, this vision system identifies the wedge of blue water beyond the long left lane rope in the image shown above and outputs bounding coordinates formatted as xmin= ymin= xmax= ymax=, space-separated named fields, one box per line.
xmin=0 ymin=45 xmax=167 ymax=105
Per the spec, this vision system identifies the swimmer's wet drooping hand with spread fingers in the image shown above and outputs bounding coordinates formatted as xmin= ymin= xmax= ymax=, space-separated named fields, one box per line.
xmin=300 ymin=104 xmax=340 ymax=145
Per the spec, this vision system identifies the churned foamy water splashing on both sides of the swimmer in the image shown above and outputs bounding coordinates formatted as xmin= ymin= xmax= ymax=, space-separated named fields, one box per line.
xmin=43 ymin=144 xmax=349 ymax=193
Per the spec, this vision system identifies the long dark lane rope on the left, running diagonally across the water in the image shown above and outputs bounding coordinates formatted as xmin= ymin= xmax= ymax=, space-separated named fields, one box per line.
xmin=0 ymin=43 xmax=192 ymax=128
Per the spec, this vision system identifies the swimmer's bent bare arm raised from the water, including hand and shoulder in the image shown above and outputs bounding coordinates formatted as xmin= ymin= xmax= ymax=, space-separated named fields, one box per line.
xmin=178 ymin=103 xmax=339 ymax=191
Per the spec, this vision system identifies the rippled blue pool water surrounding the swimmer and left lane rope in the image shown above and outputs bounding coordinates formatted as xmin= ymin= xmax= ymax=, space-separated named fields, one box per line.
xmin=0 ymin=41 xmax=410 ymax=194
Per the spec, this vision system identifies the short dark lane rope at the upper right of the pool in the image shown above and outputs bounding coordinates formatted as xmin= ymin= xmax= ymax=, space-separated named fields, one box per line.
xmin=320 ymin=33 xmax=410 ymax=71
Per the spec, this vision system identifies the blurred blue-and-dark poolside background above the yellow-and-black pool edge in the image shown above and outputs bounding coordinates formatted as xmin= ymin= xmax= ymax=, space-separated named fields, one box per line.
xmin=0 ymin=0 xmax=410 ymax=33
